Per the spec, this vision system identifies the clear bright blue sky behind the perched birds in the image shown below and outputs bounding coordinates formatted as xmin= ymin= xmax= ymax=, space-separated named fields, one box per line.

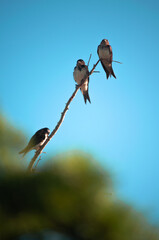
xmin=0 ymin=0 xmax=159 ymax=223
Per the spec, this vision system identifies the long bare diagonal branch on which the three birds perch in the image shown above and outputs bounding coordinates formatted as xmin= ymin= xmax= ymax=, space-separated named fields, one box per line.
xmin=28 ymin=59 xmax=100 ymax=172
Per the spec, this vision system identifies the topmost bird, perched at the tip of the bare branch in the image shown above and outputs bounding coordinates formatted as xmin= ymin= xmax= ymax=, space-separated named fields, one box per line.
xmin=97 ymin=39 xmax=116 ymax=79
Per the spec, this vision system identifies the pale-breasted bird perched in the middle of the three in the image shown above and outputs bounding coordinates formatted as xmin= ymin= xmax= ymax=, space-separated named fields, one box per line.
xmin=73 ymin=59 xmax=91 ymax=103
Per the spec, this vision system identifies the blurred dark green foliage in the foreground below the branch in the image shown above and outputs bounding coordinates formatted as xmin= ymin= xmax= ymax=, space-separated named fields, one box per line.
xmin=0 ymin=115 xmax=159 ymax=240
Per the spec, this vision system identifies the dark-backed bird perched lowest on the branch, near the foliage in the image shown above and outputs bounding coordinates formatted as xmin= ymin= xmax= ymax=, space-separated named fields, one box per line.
xmin=19 ymin=128 xmax=50 ymax=157
